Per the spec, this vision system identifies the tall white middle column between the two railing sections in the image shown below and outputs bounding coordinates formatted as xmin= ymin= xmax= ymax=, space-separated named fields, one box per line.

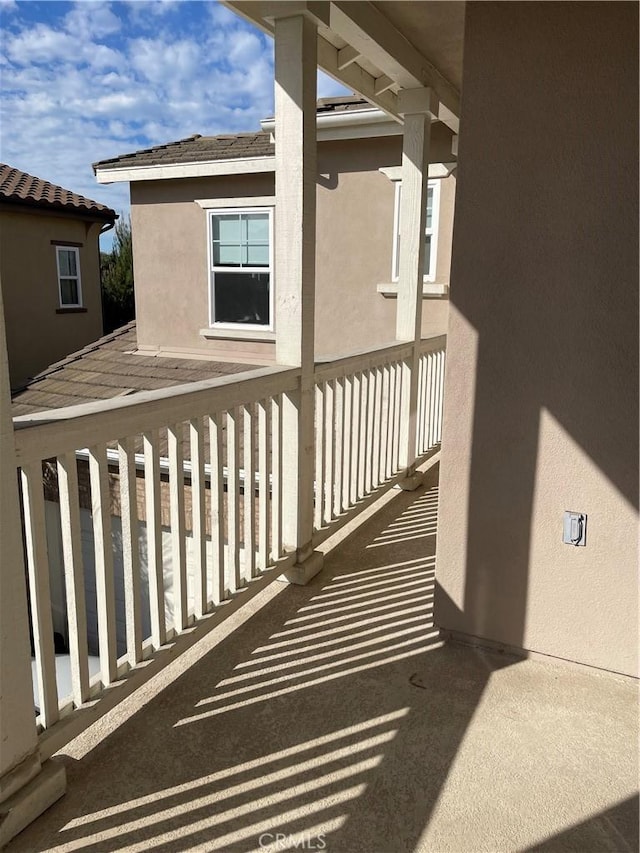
xmin=272 ymin=3 xmax=329 ymax=583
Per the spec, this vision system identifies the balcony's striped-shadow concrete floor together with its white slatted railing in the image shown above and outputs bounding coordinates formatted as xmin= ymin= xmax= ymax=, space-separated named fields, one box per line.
xmin=2 ymin=338 xmax=635 ymax=853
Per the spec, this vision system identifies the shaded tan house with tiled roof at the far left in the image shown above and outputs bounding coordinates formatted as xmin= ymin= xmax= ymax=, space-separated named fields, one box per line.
xmin=0 ymin=164 xmax=117 ymax=388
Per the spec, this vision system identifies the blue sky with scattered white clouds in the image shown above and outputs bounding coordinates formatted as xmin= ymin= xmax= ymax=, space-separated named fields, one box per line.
xmin=0 ymin=0 xmax=346 ymax=250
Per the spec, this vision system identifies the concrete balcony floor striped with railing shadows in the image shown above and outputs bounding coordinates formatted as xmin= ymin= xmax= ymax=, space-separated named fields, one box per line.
xmin=8 ymin=471 xmax=638 ymax=853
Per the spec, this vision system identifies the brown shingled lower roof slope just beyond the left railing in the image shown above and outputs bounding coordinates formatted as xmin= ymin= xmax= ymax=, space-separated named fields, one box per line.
xmin=12 ymin=321 xmax=253 ymax=416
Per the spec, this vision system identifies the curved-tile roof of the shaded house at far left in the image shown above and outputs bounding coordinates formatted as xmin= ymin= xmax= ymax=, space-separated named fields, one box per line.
xmin=0 ymin=163 xmax=118 ymax=222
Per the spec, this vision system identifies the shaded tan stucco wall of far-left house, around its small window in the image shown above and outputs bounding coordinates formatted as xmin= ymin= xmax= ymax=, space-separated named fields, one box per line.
xmin=0 ymin=207 xmax=102 ymax=388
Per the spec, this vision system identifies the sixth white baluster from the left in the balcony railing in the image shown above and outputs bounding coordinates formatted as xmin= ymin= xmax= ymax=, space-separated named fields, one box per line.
xmin=167 ymin=424 xmax=189 ymax=632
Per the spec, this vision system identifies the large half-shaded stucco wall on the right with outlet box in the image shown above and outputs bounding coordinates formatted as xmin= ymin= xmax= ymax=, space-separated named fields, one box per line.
xmin=436 ymin=3 xmax=638 ymax=674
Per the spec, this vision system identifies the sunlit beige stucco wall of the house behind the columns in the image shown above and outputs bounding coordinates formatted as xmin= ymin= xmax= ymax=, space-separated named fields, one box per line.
xmin=131 ymin=128 xmax=455 ymax=363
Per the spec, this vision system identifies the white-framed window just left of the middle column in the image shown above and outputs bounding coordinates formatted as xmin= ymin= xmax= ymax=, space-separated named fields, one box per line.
xmin=208 ymin=208 xmax=273 ymax=330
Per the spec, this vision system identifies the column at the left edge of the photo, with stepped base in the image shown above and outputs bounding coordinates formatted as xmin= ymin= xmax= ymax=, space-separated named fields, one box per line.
xmin=0 ymin=282 xmax=66 ymax=848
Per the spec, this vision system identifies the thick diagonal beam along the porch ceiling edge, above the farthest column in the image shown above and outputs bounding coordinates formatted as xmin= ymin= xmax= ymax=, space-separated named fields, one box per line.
xmin=331 ymin=0 xmax=460 ymax=132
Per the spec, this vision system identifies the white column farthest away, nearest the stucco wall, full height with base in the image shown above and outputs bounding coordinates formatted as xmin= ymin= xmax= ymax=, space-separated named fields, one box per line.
xmin=396 ymin=89 xmax=438 ymax=489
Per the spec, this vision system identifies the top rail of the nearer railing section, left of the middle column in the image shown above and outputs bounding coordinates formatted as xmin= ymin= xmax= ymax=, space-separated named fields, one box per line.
xmin=13 ymin=367 xmax=300 ymax=464
